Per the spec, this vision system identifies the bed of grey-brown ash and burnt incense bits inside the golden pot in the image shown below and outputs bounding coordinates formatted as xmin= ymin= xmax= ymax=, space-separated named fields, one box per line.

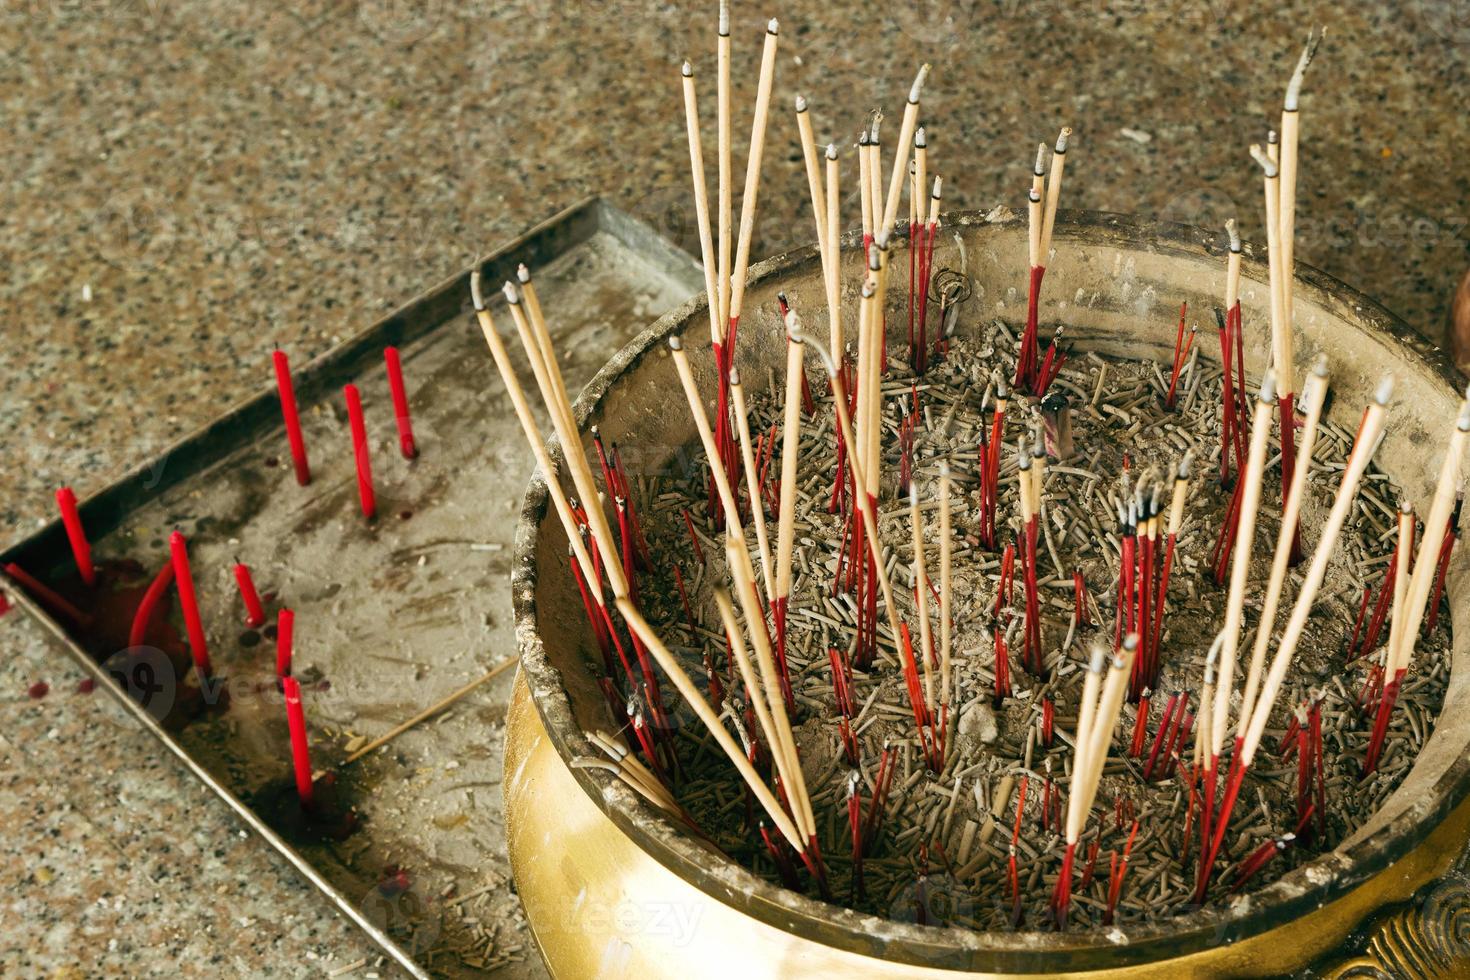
xmin=626 ymin=320 xmax=1458 ymax=929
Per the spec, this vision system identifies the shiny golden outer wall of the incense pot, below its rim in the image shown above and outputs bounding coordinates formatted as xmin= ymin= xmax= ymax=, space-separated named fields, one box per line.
xmin=504 ymin=673 xmax=1470 ymax=980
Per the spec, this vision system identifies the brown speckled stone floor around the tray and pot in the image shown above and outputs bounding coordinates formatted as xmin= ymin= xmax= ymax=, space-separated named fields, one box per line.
xmin=0 ymin=0 xmax=1470 ymax=976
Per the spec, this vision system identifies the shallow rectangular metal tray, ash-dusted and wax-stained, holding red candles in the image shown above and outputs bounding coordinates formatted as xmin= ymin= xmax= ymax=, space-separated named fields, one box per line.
xmin=0 ymin=198 xmax=703 ymax=977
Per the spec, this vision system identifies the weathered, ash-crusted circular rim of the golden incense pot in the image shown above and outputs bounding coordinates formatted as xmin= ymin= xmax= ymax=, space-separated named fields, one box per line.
xmin=507 ymin=207 xmax=1470 ymax=973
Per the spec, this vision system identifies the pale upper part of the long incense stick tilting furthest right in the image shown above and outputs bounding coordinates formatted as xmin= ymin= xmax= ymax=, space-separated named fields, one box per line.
xmin=1241 ymin=378 xmax=1387 ymax=765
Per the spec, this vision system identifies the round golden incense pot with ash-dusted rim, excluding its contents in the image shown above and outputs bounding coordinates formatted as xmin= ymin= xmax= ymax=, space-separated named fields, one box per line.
xmin=504 ymin=210 xmax=1470 ymax=979
